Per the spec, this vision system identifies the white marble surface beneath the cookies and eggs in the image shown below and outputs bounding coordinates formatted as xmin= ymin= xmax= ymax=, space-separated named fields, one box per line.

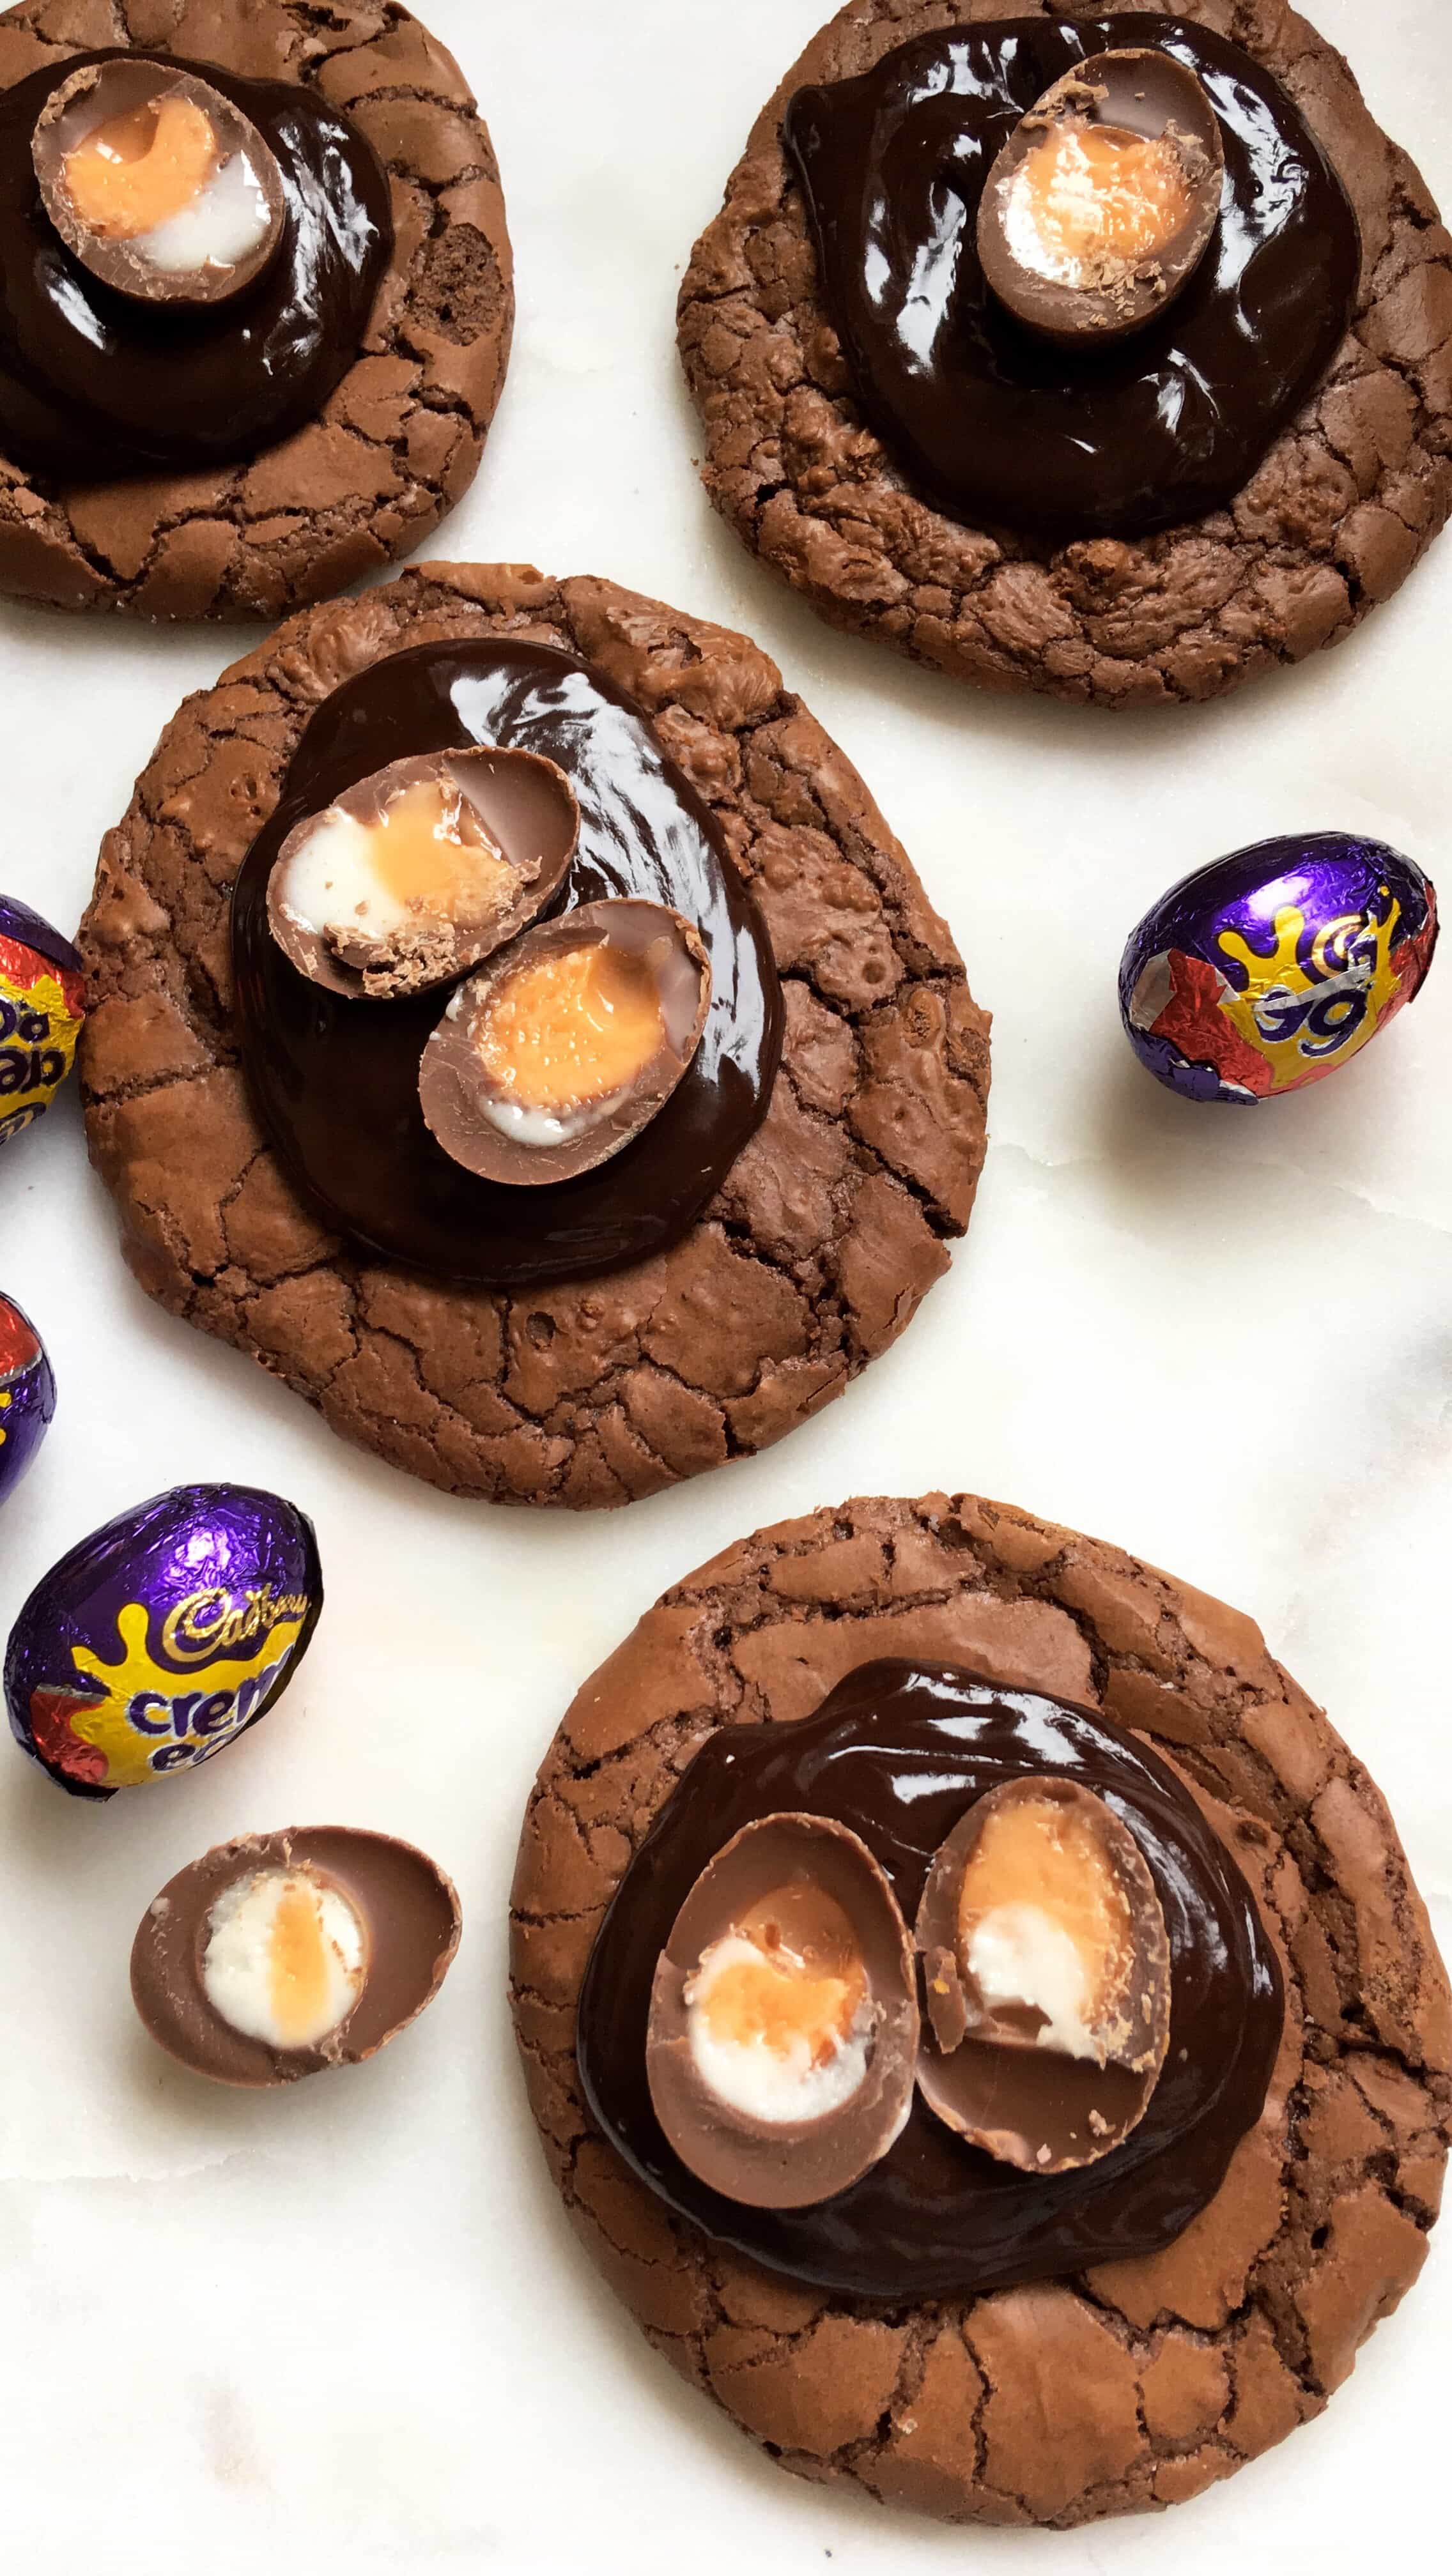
xmin=0 ymin=0 xmax=1452 ymax=2576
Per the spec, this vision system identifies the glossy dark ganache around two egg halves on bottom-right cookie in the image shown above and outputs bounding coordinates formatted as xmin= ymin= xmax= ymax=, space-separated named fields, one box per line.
xmin=578 ymin=1662 xmax=1285 ymax=2301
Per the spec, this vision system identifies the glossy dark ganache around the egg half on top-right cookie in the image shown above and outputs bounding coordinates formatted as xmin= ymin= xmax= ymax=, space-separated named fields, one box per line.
xmin=787 ymin=13 xmax=1359 ymax=539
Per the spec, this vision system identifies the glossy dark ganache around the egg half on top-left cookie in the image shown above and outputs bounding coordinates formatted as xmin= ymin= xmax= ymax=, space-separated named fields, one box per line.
xmin=0 ymin=47 xmax=392 ymax=482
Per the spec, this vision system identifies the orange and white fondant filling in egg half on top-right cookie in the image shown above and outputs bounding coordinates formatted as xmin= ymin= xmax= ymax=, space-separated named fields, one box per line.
xmin=1019 ymin=118 xmax=1189 ymax=286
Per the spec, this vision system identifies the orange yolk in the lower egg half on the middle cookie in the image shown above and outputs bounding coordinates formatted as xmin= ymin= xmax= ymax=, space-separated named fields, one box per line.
xmin=475 ymin=940 xmax=665 ymax=1110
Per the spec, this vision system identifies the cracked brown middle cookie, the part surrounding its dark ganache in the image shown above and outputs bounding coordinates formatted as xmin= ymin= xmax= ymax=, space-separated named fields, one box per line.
xmin=82 ymin=564 xmax=988 ymax=1507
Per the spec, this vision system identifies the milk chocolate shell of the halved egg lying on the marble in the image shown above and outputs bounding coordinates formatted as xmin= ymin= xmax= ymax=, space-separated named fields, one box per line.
xmin=132 ymin=1824 xmax=459 ymax=2087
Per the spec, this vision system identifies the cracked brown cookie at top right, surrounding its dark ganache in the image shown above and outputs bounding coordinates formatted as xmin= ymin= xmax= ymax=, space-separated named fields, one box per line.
xmin=681 ymin=0 xmax=1452 ymax=706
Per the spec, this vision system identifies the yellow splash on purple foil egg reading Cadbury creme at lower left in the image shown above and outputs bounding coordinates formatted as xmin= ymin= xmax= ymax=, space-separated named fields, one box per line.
xmin=70 ymin=1602 xmax=307 ymax=1788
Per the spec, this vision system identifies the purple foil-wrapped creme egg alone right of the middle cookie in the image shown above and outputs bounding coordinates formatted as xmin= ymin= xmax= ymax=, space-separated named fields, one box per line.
xmin=1119 ymin=832 xmax=1437 ymax=1103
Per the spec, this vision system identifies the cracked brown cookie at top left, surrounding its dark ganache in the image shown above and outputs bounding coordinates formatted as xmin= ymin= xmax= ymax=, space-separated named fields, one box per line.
xmin=0 ymin=0 xmax=513 ymax=618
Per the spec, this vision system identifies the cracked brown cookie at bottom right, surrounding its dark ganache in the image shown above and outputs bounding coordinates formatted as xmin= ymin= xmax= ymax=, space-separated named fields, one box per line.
xmin=511 ymin=1494 xmax=1452 ymax=2527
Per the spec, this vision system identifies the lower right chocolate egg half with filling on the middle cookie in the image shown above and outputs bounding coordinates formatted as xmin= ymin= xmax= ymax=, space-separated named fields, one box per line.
xmin=418 ymin=899 xmax=712 ymax=1188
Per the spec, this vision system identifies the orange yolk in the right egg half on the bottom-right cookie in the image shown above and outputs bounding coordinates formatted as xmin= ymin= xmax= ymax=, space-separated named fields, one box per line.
xmin=957 ymin=1798 xmax=1135 ymax=2017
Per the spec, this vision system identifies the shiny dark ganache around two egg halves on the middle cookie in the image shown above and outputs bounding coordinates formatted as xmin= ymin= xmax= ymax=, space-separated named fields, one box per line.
xmin=232 ymin=636 xmax=782 ymax=1288
